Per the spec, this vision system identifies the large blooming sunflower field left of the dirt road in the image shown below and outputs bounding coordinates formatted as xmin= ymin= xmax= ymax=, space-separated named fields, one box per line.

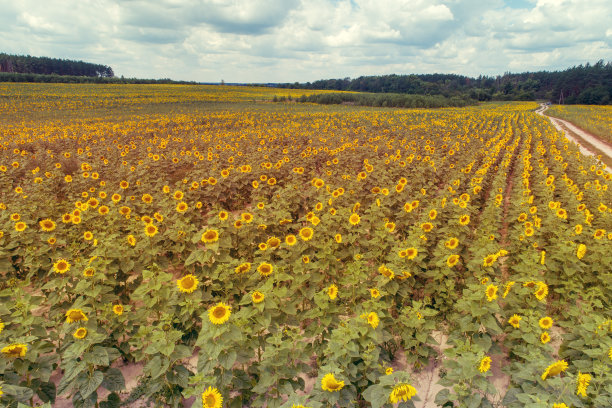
xmin=0 ymin=84 xmax=612 ymax=408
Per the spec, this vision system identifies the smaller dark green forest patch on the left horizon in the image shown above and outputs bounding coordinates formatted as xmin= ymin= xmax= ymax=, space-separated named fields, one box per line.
xmin=0 ymin=53 xmax=115 ymax=78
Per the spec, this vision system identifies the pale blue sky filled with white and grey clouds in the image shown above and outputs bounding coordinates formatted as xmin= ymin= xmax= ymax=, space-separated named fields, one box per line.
xmin=0 ymin=0 xmax=612 ymax=82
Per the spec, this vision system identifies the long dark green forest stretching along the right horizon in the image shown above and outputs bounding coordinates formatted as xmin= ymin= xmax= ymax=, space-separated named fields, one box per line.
xmin=275 ymin=60 xmax=612 ymax=105
